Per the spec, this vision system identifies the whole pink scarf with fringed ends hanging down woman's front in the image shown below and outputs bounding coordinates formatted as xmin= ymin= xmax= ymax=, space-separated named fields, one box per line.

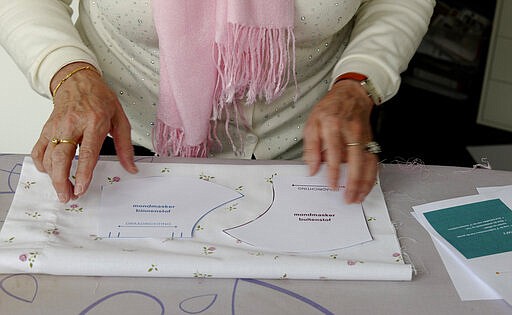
xmin=152 ymin=0 xmax=295 ymax=157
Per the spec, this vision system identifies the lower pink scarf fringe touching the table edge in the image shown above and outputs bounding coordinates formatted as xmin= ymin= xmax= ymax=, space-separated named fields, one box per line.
xmin=153 ymin=119 xmax=210 ymax=157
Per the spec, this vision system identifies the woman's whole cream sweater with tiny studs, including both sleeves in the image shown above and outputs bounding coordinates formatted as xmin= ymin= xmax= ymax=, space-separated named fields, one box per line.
xmin=0 ymin=0 xmax=435 ymax=159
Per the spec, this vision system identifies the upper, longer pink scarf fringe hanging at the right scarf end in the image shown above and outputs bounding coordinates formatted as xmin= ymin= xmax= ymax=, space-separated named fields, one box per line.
xmin=212 ymin=23 xmax=296 ymax=120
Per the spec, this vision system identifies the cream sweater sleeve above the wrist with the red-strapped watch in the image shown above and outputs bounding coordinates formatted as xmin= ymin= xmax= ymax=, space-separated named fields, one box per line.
xmin=332 ymin=0 xmax=435 ymax=102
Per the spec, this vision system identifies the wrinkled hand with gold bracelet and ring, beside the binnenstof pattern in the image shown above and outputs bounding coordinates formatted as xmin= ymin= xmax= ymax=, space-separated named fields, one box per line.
xmin=32 ymin=63 xmax=137 ymax=203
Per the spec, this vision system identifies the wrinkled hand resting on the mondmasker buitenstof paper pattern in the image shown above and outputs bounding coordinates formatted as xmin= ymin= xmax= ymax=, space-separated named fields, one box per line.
xmin=303 ymin=80 xmax=378 ymax=203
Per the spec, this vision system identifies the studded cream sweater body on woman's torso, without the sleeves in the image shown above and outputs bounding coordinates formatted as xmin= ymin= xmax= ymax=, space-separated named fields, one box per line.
xmin=77 ymin=0 xmax=361 ymax=159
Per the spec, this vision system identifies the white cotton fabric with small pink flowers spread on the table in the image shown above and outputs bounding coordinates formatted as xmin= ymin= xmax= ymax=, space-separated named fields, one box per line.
xmin=0 ymin=158 xmax=412 ymax=280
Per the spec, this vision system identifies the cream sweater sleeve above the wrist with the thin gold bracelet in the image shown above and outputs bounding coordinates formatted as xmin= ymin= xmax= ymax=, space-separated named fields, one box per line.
xmin=0 ymin=0 xmax=98 ymax=98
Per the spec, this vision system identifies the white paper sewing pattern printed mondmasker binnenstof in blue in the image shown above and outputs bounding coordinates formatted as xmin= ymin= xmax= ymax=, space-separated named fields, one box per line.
xmin=98 ymin=176 xmax=243 ymax=238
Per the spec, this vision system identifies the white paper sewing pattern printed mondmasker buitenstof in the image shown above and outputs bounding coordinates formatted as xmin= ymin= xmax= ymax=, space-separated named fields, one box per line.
xmin=224 ymin=176 xmax=372 ymax=253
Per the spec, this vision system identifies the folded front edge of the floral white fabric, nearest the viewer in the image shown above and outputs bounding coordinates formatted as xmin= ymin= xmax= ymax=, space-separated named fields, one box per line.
xmin=0 ymin=248 xmax=413 ymax=281
